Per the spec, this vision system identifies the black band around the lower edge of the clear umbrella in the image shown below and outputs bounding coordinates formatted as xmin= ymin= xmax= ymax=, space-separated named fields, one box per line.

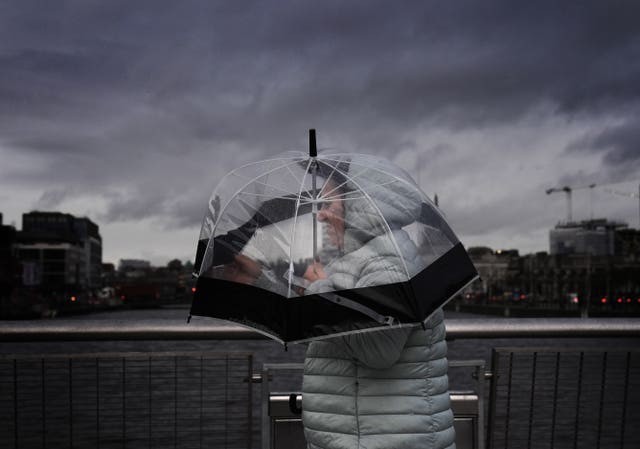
xmin=191 ymin=243 xmax=477 ymax=342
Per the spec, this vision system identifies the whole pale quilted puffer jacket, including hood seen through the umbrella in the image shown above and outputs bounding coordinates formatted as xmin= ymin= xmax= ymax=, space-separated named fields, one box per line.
xmin=302 ymin=172 xmax=455 ymax=449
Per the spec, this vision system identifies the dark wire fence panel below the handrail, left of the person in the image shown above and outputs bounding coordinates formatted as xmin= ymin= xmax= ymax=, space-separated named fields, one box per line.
xmin=0 ymin=351 xmax=253 ymax=449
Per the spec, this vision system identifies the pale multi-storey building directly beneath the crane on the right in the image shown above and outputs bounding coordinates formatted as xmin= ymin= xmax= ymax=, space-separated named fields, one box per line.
xmin=549 ymin=218 xmax=627 ymax=256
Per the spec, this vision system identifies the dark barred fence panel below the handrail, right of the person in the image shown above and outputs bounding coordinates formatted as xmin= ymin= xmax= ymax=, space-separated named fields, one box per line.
xmin=489 ymin=348 xmax=640 ymax=449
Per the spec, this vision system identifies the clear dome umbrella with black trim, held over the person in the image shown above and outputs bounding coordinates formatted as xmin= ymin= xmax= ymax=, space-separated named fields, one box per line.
xmin=191 ymin=130 xmax=478 ymax=343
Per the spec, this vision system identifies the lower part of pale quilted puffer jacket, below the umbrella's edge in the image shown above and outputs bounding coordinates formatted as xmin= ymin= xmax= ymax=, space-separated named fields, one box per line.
xmin=302 ymin=311 xmax=455 ymax=449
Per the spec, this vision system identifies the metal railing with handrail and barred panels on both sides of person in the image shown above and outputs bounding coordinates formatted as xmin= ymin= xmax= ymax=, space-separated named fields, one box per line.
xmin=0 ymin=318 xmax=640 ymax=448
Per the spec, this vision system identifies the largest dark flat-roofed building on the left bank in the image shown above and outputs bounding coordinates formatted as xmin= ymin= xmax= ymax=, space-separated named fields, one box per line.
xmin=15 ymin=211 xmax=102 ymax=291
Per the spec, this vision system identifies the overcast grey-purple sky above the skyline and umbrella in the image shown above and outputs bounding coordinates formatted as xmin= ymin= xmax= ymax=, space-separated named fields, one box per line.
xmin=0 ymin=0 xmax=640 ymax=264
